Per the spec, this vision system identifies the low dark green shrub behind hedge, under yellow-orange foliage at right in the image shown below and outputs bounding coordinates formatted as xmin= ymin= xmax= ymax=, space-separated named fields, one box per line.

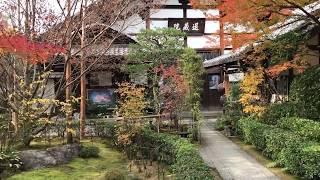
xmin=259 ymin=102 xmax=299 ymax=125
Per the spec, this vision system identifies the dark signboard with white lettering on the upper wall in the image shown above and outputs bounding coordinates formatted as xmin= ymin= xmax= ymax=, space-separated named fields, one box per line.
xmin=168 ymin=18 xmax=206 ymax=35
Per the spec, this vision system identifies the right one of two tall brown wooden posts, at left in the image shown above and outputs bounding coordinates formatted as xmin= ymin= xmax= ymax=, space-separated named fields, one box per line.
xmin=80 ymin=0 xmax=87 ymax=140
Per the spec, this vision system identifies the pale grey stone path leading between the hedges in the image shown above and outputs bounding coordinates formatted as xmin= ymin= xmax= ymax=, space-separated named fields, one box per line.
xmin=200 ymin=119 xmax=280 ymax=180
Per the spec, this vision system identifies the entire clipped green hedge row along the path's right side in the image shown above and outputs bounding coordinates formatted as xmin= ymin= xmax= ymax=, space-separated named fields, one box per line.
xmin=239 ymin=118 xmax=320 ymax=179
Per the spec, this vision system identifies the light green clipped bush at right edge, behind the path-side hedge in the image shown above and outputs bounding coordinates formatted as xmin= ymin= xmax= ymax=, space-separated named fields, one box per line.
xmin=277 ymin=117 xmax=320 ymax=142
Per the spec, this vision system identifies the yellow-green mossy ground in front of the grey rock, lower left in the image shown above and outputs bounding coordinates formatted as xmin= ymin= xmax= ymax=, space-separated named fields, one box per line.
xmin=9 ymin=141 xmax=127 ymax=180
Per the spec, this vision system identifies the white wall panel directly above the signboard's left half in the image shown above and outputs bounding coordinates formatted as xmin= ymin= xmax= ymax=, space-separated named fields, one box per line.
xmin=150 ymin=9 xmax=183 ymax=18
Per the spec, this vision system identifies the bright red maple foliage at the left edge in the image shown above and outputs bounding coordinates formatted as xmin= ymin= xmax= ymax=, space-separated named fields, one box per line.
xmin=0 ymin=33 xmax=65 ymax=64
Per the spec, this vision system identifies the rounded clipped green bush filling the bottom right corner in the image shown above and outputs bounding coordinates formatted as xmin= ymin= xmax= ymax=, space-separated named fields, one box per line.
xmin=283 ymin=142 xmax=320 ymax=179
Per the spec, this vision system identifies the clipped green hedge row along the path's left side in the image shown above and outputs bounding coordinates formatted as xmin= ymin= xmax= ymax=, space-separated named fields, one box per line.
xmin=139 ymin=129 xmax=213 ymax=180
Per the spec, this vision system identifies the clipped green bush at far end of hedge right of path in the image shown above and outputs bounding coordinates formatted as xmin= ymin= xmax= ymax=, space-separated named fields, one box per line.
xmin=239 ymin=118 xmax=272 ymax=150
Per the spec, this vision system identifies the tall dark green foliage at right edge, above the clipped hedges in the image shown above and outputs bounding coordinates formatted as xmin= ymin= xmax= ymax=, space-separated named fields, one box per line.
xmin=290 ymin=65 xmax=320 ymax=121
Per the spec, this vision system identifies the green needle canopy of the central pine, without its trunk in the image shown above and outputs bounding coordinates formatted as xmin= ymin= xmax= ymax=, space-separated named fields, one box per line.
xmin=126 ymin=28 xmax=185 ymax=74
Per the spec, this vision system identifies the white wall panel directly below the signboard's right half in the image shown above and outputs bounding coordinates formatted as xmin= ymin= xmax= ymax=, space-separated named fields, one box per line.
xmin=187 ymin=35 xmax=220 ymax=49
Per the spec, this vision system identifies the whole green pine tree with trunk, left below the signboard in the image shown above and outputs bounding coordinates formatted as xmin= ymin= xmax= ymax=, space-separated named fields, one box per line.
xmin=123 ymin=28 xmax=185 ymax=114
